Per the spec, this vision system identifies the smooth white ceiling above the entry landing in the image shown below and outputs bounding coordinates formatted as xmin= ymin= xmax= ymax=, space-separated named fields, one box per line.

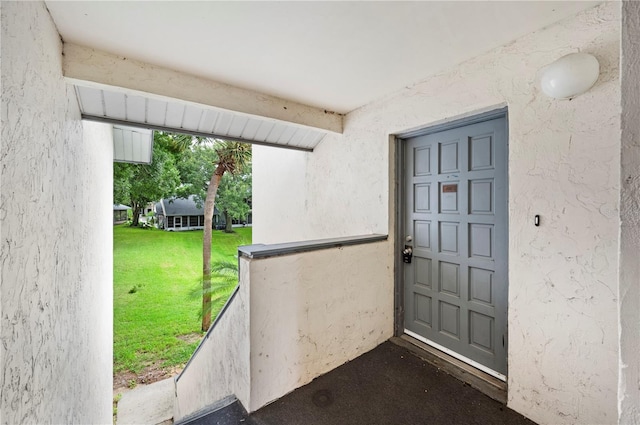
xmin=46 ymin=0 xmax=600 ymax=113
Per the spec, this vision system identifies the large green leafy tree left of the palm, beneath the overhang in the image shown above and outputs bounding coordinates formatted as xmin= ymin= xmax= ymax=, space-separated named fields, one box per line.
xmin=113 ymin=132 xmax=180 ymax=226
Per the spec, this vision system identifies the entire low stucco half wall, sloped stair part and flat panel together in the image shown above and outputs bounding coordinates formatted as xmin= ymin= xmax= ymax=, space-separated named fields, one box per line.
xmin=174 ymin=242 xmax=393 ymax=420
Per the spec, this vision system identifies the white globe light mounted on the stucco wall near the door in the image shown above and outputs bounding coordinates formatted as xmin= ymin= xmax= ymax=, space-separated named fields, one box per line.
xmin=540 ymin=53 xmax=600 ymax=99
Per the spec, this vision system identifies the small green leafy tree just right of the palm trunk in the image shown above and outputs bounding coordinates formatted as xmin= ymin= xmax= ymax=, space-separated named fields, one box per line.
xmin=216 ymin=172 xmax=251 ymax=233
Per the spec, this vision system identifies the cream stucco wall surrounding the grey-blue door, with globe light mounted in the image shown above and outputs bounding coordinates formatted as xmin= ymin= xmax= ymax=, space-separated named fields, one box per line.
xmin=253 ymin=3 xmax=620 ymax=423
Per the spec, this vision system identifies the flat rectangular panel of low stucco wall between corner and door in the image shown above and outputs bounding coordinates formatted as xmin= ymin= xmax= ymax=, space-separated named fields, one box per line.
xmin=247 ymin=242 xmax=393 ymax=411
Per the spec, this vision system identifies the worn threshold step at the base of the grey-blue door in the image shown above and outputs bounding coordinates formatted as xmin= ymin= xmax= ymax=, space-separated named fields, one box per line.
xmin=391 ymin=335 xmax=507 ymax=404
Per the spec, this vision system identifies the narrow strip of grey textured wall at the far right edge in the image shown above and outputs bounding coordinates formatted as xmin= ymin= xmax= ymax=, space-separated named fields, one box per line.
xmin=618 ymin=1 xmax=640 ymax=424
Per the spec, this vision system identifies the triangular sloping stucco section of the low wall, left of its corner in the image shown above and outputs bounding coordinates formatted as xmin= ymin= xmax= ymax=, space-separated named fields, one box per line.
xmin=173 ymin=258 xmax=251 ymax=421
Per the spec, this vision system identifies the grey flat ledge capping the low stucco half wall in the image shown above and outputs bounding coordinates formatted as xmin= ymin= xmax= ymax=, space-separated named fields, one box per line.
xmin=238 ymin=234 xmax=388 ymax=259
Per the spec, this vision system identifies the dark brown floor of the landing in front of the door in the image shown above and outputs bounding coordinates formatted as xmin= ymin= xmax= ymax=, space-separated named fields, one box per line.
xmin=192 ymin=342 xmax=533 ymax=425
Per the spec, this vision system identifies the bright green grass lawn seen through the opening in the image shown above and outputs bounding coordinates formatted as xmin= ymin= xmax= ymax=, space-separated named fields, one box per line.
xmin=113 ymin=225 xmax=251 ymax=373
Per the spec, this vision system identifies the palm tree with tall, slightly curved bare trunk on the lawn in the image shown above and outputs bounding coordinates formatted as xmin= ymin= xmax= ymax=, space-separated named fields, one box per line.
xmin=202 ymin=140 xmax=251 ymax=331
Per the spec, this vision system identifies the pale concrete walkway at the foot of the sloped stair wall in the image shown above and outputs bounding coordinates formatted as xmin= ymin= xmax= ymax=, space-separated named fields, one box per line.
xmin=116 ymin=378 xmax=175 ymax=425
